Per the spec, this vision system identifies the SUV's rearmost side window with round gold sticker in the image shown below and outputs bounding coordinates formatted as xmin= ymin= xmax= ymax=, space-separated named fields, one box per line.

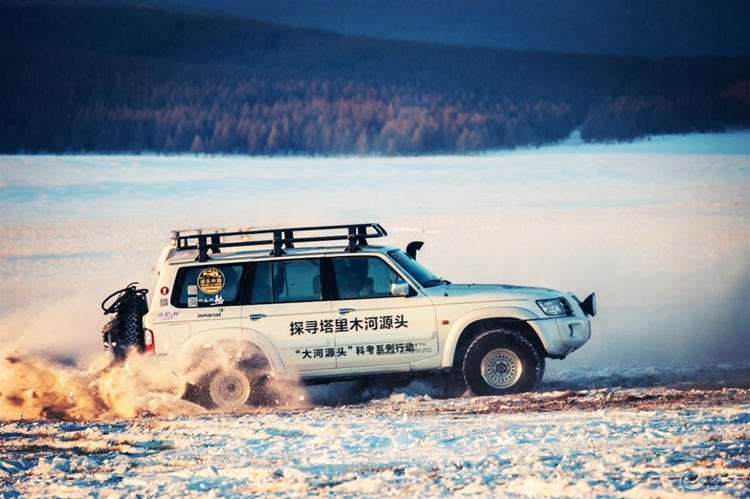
xmin=172 ymin=265 xmax=243 ymax=308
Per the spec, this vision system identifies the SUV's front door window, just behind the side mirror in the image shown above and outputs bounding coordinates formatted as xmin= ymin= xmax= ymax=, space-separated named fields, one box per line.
xmin=333 ymin=256 xmax=398 ymax=300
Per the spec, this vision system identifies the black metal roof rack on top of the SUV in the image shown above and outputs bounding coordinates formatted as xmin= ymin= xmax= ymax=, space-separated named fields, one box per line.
xmin=172 ymin=223 xmax=388 ymax=262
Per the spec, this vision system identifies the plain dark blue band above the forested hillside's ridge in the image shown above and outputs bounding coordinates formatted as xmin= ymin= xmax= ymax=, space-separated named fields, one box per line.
xmin=47 ymin=0 xmax=750 ymax=58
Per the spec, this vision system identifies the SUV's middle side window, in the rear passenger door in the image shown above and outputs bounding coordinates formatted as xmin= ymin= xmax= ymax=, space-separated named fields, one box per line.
xmin=251 ymin=258 xmax=322 ymax=304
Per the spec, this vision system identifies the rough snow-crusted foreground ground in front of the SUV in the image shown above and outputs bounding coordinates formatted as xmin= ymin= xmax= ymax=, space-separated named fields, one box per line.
xmin=0 ymin=394 xmax=750 ymax=498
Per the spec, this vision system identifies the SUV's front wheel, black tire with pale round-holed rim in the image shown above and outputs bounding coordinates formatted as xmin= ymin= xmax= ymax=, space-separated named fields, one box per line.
xmin=463 ymin=329 xmax=544 ymax=395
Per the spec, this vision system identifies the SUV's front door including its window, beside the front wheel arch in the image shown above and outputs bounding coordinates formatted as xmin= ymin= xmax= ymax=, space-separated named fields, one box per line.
xmin=331 ymin=254 xmax=438 ymax=373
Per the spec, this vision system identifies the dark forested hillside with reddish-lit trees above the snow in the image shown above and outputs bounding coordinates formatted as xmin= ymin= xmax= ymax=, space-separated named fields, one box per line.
xmin=0 ymin=6 xmax=750 ymax=154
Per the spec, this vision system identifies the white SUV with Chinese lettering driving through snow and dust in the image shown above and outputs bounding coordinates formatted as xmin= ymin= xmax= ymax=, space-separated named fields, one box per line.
xmin=102 ymin=223 xmax=596 ymax=410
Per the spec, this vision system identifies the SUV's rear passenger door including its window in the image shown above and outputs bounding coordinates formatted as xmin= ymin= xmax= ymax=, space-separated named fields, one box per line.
xmin=242 ymin=258 xmax=336 ymax=373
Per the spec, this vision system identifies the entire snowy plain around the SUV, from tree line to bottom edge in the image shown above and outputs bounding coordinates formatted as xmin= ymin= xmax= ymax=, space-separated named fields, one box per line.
xmin=0 ymin=132 xmax=750 ymax=497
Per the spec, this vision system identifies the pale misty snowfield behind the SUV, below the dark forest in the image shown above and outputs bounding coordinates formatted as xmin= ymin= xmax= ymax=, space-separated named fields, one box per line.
xmin=0 ymin=132 xmax=750 ymax=370
